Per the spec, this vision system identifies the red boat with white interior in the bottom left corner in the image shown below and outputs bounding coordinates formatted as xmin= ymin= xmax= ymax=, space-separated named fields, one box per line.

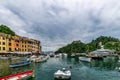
xmin=0 ymin=70 xmax=34 ymax=80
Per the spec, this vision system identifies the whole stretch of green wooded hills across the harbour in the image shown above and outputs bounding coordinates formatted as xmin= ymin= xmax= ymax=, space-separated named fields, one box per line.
xmin=55 ymin=36 xmax=120 ymax=53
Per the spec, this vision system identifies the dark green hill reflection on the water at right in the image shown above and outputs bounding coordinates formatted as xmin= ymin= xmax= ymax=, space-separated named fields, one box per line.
xmin=80 ymin=57 xmax=119 ymax=70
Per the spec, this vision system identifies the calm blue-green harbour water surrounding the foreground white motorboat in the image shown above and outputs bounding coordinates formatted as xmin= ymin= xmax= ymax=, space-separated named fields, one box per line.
xmin=4 ymin=58 xmax=120 ymax=80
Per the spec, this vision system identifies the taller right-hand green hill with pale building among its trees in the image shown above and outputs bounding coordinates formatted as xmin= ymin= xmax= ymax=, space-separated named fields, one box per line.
xmin=87 ymin=36 xmax=120 ymax=51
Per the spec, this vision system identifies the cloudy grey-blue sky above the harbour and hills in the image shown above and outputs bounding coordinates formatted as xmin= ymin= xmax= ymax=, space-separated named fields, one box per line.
xmin=0 ymin=0 xmax=120 ymax=51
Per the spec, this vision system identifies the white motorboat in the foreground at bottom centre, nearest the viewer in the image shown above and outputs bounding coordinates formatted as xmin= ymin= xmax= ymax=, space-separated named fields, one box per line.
xmin=54 ymin=68 xmax=71 ymax=79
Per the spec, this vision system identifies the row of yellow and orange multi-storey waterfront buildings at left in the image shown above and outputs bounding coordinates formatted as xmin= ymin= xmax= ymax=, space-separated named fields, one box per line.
xmin=0 ymin=33 xmax=41 ymax=54
